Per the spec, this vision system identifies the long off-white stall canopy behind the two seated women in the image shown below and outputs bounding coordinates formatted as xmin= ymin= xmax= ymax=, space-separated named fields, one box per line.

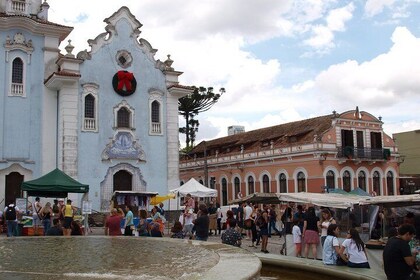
xmin=277 ymin=192 xmax=365 ymax=209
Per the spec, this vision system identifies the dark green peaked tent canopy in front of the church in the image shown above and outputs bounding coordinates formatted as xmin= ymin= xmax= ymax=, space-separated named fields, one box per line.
xmin=22 ymin=168 xmax=89 ymax=198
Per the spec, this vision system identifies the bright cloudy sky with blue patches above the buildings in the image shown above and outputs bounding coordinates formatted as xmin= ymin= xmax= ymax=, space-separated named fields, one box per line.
xmin=48 ymin=0 xmax=420 ymax=147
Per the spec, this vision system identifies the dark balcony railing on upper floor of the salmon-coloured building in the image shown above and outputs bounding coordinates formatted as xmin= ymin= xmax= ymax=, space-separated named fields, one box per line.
xmin=337 ymin=146 xmax=391 ymax=160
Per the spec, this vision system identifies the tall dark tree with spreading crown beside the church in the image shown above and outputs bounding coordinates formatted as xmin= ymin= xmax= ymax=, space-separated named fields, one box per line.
xmin=178 ymin=87 xmax=225 ymax=151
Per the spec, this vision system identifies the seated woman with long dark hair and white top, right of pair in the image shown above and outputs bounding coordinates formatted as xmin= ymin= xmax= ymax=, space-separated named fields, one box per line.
xmin=340 ymin=228 xmax=370 ymax=268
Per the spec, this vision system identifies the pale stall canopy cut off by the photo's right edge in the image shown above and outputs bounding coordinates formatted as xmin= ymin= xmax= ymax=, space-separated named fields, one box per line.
xmin=360 ymin=194 xmax=420 ymax=207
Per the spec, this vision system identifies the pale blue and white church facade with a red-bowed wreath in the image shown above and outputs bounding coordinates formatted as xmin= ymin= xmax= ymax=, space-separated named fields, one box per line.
xmin=0 ymin=0 xmax=193 ymax=211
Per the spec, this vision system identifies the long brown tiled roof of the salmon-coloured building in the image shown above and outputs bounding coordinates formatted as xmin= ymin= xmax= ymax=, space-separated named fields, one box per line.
xmin=190 ymin=114 xmax=334 ymax=156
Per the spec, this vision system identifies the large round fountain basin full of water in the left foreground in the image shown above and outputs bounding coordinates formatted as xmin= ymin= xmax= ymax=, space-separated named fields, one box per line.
xmin=0 ymin=236 xmax=261 ymax=280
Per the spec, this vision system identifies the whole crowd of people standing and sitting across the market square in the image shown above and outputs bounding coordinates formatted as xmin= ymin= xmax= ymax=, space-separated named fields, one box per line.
xmin=3 ymin=194 xmax=418 ymax=280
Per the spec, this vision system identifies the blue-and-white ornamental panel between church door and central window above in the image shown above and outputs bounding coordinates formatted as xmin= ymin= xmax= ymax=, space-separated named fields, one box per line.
xmin=102 ymin=131 xmax=146 ymax=161
